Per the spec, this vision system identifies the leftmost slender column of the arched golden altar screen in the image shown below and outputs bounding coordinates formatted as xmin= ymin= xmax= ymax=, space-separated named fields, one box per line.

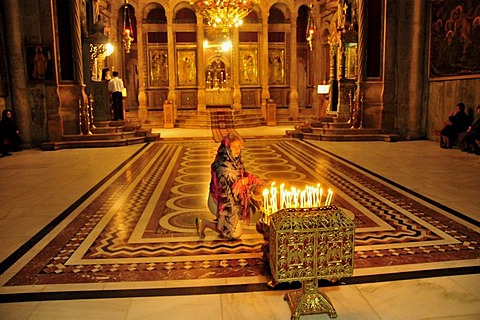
xmin=137 ymin=19 xmax=148 ymax=124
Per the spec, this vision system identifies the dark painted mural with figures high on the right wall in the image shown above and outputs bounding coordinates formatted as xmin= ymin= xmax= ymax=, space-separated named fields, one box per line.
xmin=430 ymin=0 xmax=480 ymax=77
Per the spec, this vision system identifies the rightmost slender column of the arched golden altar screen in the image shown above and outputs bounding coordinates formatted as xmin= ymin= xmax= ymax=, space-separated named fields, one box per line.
xmin=288 ymin=12 xmax=298 ymax=120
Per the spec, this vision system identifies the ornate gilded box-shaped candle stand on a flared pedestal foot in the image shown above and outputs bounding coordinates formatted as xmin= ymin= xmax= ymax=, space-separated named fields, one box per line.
xmin=266 ymin=206 xmax=355 ymax=320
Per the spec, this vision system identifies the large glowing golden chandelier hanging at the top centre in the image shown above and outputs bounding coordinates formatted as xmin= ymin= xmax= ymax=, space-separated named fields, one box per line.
xmin=190 ymin=0 xmax=258 ymax=31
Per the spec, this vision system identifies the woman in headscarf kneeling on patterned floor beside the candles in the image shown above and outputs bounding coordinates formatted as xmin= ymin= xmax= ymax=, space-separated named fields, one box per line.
xmin=195 ymin=133 xmax=261 ymax=240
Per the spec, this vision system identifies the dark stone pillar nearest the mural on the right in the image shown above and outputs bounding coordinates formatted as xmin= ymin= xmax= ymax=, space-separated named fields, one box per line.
xmin=406 ymin=0 xmax=427 ymax=140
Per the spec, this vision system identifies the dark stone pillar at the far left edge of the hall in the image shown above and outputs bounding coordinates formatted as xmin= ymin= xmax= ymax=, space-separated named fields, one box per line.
xmin=2 ymin=0 xmax=32 ymax=148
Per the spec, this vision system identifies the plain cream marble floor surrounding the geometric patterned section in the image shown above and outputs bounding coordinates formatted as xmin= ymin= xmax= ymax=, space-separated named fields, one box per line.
xmin=0 ymin=127 xmax=480 ymax=319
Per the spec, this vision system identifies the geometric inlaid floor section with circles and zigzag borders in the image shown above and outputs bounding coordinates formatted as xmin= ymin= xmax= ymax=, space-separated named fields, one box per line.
xmin=6 ymin=138 xmax=480 ymax=286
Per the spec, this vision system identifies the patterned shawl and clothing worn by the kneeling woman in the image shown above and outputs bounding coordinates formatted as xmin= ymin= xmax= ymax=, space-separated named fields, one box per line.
xmin=210 ymin=134 xmax=260 ymax=239
